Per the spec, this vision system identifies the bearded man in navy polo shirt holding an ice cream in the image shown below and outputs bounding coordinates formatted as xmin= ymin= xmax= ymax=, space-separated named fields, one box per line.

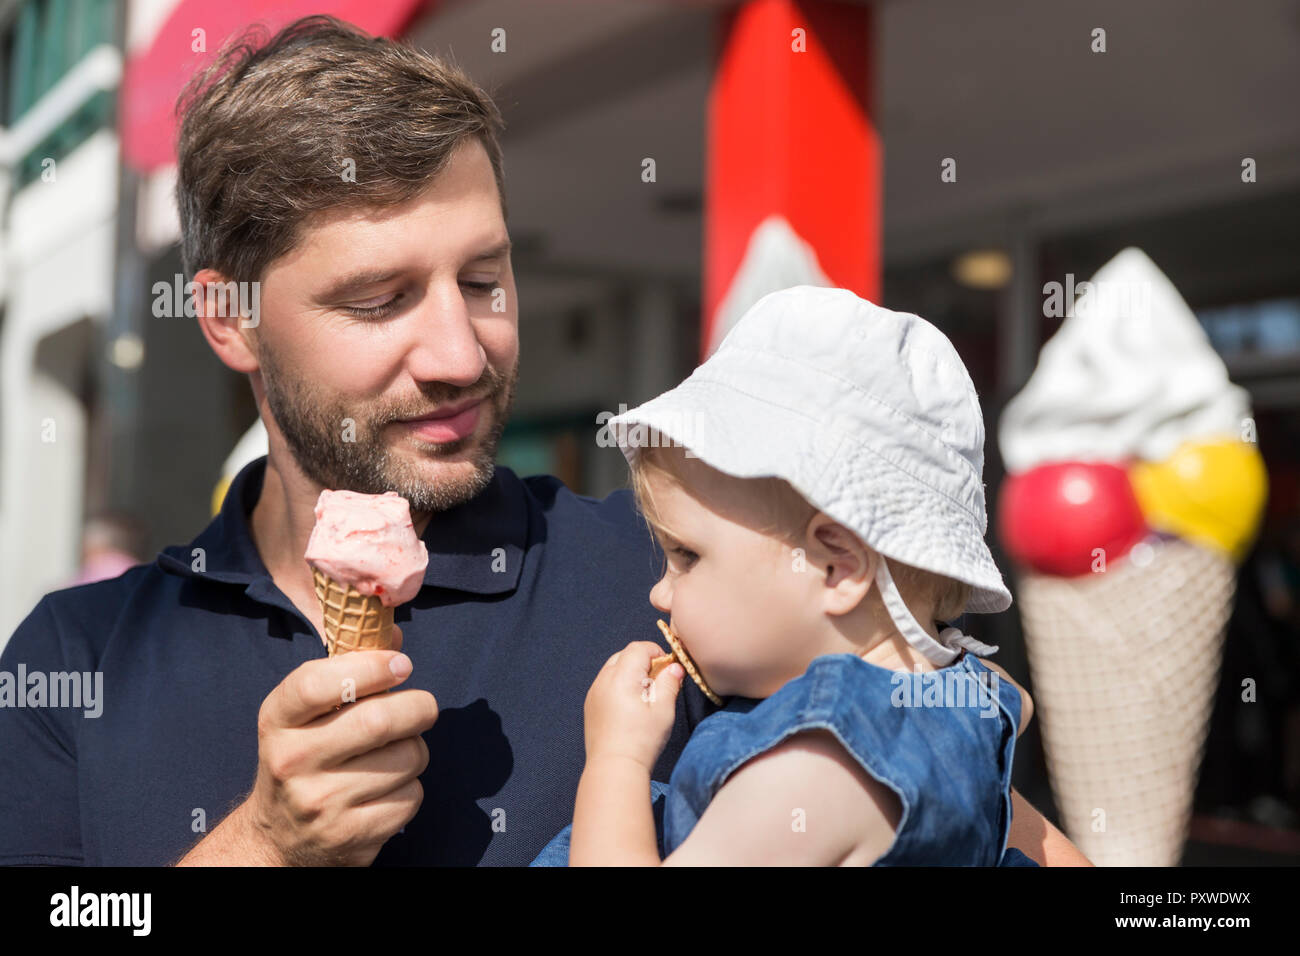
xmin=0 ymin=17 xmax=1079 ymax=865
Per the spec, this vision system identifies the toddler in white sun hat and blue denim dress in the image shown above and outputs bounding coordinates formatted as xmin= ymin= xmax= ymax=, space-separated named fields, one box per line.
xmin=534 ymin=286 xmax=1032 ymax=866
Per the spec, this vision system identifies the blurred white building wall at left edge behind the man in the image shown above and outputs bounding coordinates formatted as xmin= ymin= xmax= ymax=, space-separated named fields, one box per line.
xmin=0 ymin=130 xmax=118 ymax=649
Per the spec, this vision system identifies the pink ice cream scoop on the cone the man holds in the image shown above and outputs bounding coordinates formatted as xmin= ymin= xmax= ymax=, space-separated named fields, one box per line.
xmin=303 ymin=490 xmax=429 ymax=607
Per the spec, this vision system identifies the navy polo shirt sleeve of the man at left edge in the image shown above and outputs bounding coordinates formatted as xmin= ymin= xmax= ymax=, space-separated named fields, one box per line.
xmin=0 ymin=596 xmax=85 ymax=866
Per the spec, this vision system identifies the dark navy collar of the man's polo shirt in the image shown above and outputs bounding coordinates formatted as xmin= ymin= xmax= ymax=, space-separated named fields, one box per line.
xmin=156 ymin=455 xmax=528 ymax=594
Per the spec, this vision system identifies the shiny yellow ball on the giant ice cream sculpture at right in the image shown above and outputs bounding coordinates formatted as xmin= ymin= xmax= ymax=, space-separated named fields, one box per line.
xmin=1128 ymin=438 xmax=1269 ymax=562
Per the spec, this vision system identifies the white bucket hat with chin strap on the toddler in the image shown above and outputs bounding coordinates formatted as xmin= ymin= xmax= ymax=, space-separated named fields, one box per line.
xmin=608 ymin=285 xmax=1011 ymax=666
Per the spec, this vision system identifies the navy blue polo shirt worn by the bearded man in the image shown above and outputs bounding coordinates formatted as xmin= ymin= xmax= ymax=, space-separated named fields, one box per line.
xmin=0 ymin=458 xmax=714 ymax=866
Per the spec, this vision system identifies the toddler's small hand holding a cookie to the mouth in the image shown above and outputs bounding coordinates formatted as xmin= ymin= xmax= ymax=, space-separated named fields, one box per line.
xmin=584 ymin=641 xmax=686 ymax=771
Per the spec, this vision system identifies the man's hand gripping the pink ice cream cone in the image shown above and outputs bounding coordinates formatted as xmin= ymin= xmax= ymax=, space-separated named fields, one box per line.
xmin=179 ymin=629 xmax=438 ymax=866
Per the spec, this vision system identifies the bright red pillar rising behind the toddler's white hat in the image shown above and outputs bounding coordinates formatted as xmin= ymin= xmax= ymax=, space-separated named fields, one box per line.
xmin=701 ymin=0 xmax=881 ymax=359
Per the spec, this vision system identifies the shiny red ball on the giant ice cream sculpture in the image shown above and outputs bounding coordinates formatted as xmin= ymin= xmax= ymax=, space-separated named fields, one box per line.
xmin=997 ymin=462 xmax=1148 ymax=578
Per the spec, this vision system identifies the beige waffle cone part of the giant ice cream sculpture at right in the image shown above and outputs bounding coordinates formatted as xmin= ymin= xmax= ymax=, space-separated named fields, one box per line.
xmin=1017 ymin=540 xmax=1236 ymax=866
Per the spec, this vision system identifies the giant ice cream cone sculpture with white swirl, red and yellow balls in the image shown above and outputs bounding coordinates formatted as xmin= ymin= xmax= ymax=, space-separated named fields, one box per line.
xmin=998 ymin=248 xmax=1266 ymax=866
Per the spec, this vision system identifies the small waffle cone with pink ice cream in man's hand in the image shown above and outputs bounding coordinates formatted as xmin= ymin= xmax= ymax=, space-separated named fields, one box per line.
xmin=304 ymin=490 xmax=429 ymax=657
